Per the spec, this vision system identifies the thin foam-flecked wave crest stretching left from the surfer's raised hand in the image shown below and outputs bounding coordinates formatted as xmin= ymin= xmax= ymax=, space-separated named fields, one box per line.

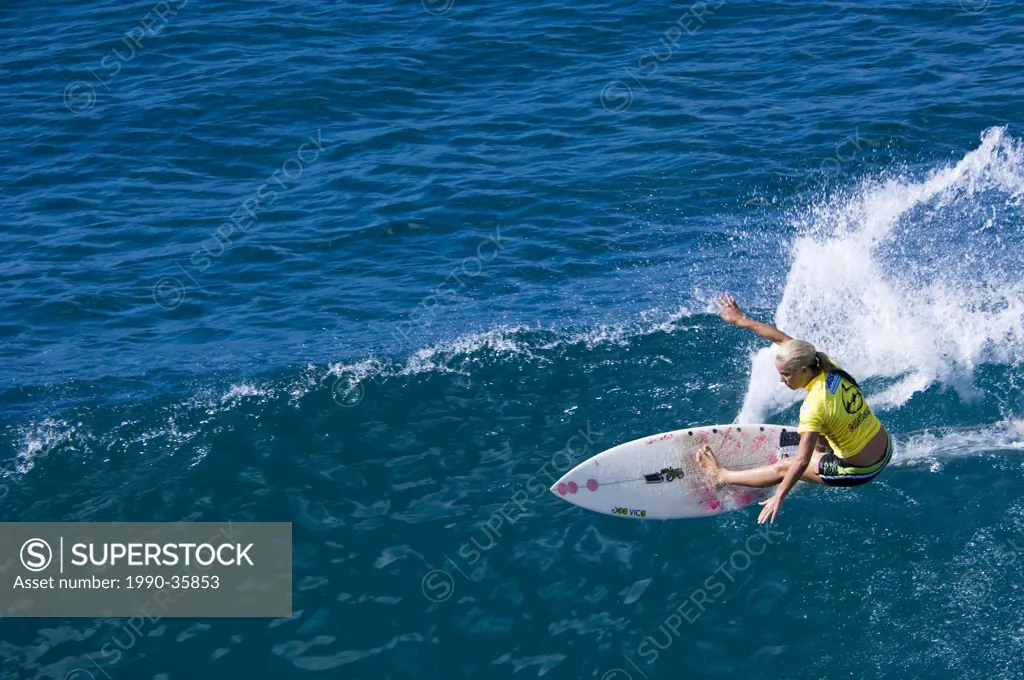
xmin=0 ymin=308 xmax=690 ymax=479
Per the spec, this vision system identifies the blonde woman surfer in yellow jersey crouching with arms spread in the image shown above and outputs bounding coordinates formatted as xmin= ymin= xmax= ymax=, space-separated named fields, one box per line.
xmin=697 ymin=295 xmax=893 ymax=523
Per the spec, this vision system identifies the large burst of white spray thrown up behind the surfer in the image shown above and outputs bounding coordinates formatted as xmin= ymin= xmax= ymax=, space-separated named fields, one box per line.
xmin=737 ymin=128 xmax=1024 ymax=422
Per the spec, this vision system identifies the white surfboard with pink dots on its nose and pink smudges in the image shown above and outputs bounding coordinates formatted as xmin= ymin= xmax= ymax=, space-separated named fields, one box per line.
xmin=551 ymin=425 xmax=800 ymax=519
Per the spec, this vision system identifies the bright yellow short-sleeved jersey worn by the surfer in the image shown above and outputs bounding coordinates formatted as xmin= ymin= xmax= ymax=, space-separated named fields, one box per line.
xmin=797 ymin=362 xmax=882 ymax=458
